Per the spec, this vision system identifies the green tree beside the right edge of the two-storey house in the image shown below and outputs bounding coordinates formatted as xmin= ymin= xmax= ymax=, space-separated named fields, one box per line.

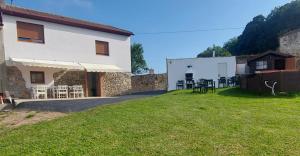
xmin=131 ymin=43 xmax=148 ymax=74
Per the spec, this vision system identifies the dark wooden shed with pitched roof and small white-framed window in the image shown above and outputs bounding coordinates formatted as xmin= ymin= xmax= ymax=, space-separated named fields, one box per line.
xmin=247 ymin=51 xmax=296 ymax=73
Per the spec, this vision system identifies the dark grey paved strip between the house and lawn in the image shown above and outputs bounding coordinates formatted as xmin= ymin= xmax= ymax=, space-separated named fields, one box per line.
xmin=15 ymin=91 xmax=164 ymax=113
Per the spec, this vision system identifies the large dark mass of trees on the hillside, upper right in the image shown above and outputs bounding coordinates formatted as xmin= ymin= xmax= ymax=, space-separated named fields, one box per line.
xmin=232 ymin=0 xmax=300 ymax=55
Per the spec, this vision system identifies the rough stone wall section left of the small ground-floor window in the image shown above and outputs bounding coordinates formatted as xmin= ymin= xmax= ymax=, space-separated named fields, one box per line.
xmin=6 ymin=66 xmax=31 ymax=99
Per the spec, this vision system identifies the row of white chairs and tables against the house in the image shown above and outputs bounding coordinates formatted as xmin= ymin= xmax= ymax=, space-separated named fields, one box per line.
xmin=32 ymin=85 xmax=84 ymax=99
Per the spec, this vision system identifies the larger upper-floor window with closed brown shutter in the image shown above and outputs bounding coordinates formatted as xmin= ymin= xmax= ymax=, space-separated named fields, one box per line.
xmin=17 ymin=21 xmax=45 ymax=43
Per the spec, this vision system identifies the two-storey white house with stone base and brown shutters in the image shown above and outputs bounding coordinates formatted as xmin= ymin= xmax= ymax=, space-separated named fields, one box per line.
xmin=0 ymin=4 xmax=133 ymax=98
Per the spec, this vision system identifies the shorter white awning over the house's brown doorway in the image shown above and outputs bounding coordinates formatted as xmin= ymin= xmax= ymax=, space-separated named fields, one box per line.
xmin=80 ymin=63 xmax=122 ymax=72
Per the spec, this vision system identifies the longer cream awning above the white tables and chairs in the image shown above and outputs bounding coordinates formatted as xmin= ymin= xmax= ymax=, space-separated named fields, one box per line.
xmin=8 ymin=58 xmax=84 ymax=70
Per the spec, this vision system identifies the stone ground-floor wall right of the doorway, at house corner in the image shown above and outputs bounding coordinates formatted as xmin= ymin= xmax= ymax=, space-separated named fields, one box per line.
xmin=101 ymin=72 xmax=131 ymax=97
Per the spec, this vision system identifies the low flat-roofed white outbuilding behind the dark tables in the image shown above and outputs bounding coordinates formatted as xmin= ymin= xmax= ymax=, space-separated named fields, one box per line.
xmin=166 ymin=56 xmax=236 ymax=91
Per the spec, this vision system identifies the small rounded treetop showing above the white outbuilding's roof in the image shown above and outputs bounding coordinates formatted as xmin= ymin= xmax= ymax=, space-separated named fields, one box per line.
xmin=197 ymin=45 xmax=231 ymax=57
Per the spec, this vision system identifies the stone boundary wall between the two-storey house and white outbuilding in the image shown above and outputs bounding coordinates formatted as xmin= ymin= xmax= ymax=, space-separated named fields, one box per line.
xmin=131 ymin=74 xmax=167 ymax=93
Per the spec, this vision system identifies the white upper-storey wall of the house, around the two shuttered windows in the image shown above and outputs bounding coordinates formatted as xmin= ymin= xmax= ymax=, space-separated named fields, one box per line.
xmin=3 ymin=15 xmax=131 ymax=72
